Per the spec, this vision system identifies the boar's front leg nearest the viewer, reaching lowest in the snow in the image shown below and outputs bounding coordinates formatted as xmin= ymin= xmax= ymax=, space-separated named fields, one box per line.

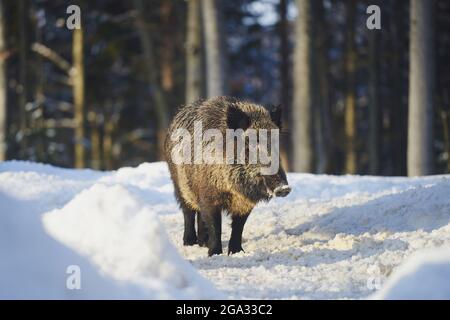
xmin=200 ymin=206 xmax=222 ymax=256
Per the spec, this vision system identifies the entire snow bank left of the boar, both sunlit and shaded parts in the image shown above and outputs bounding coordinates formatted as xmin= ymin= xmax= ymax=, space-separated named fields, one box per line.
xmin=0 ymin=162 xmax=221 ymax=299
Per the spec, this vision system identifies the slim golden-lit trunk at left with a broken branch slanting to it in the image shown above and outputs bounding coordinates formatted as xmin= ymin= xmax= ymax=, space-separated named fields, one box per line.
xmin=72 ymin=28 xmax=85 ymax=168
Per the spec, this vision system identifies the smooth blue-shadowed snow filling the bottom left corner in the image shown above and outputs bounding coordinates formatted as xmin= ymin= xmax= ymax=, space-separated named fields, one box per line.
xmin=0 ymin=193 xmax=141 ymax=299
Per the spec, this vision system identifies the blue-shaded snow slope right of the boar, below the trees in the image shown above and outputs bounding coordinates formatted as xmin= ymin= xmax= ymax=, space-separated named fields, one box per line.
xmin=294 ymin=178 xmax=450 ymax=234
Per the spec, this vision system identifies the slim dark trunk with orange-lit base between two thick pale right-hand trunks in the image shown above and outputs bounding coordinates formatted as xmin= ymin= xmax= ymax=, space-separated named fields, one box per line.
xmin=345 ymin=0 xmax=357 ymax=174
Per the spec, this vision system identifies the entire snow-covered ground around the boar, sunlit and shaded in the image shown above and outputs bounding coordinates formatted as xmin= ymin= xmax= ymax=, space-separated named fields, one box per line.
xmin=0 ymin=161 xmax=450 ymax=299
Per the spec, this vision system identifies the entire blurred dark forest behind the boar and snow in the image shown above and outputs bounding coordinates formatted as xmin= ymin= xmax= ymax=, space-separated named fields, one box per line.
xmin=0 ymin=0 xmax=450 ymax=175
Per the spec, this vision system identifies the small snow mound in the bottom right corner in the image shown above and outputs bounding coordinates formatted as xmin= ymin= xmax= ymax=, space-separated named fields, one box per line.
xmin=372 ymin=247 xmax=450 ymax=300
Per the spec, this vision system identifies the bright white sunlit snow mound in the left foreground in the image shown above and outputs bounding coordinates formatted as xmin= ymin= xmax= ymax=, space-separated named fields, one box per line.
xmin=43 ymin=184 xmax=216 ymax=299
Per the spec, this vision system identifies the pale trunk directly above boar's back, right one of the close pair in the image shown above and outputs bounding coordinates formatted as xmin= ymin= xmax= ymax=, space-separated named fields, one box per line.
xmin=202 ymin=0 xmax=226 ymax=98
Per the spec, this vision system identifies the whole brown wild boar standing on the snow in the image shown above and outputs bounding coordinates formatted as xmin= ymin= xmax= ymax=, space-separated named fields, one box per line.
xmin=165 ymin=97 xmax=291 ymax=256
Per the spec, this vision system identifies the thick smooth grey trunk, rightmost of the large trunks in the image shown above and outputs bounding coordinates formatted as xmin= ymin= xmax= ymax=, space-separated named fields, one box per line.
xmin=408 ymin=0 xmax=434 ymax=176
